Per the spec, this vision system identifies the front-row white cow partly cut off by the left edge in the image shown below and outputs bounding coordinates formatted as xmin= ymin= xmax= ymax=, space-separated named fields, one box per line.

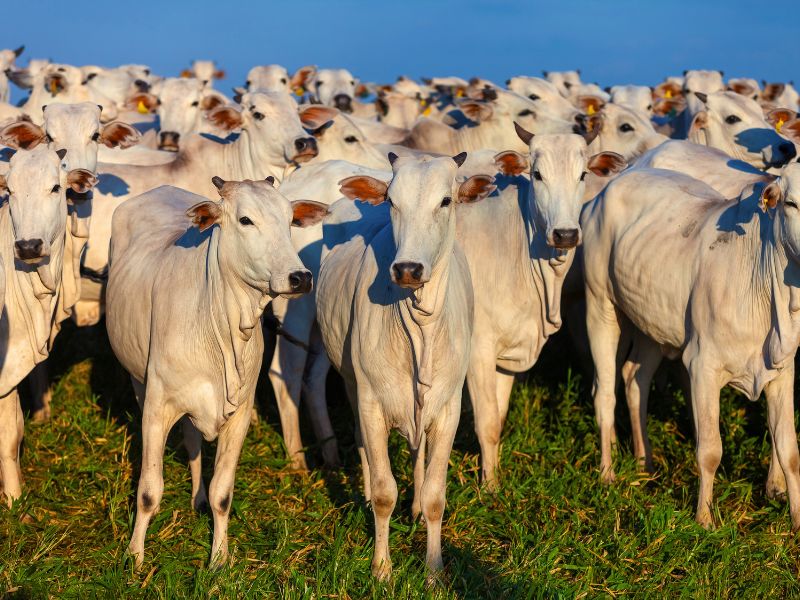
xmin=0 ymin=145 xmax=95 ymax=505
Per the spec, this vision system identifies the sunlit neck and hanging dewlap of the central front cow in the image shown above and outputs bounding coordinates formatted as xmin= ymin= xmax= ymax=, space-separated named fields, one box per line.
xmin=399 ymin=219 xmax=455 ymax=448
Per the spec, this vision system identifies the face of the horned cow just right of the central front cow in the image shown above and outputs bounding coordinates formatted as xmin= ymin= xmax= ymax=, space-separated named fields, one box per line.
xmin=495 ymin=128 xmax=626 ymax=250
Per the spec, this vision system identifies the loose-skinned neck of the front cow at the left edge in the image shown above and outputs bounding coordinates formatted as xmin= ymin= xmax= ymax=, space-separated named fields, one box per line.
xmin=0 ymin=202 xmax=65 ymax=364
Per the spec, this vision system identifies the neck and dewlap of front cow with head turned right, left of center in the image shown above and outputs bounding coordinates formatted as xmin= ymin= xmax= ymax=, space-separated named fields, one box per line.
xmin=206 ymin=226 xmax=270 ymax=419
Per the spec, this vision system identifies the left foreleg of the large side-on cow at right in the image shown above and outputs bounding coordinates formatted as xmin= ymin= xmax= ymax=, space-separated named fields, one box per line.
xmin=688 ymin=359 xmax=722 ymax=528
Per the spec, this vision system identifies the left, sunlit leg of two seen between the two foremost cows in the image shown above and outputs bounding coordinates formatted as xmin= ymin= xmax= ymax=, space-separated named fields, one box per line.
xmin=269 ymin=336 xmax=308 ymax=471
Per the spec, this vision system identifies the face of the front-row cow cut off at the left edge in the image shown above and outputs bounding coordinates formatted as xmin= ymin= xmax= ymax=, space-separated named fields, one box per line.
xmin=0 ymin=145 xmax=96 ymax=265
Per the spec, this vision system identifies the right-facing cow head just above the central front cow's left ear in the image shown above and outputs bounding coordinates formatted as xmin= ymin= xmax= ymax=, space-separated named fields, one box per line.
xmin=300 ymin=105 xmax=386 ymax=169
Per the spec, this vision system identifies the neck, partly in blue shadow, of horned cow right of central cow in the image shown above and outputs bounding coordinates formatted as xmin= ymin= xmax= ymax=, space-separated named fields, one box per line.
xmin=519 ymin=183 xmax=575 ymax=342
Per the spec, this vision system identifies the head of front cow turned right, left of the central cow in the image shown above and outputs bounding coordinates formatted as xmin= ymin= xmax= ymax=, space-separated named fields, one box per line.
xmin=187 ymin=177 xmax=328 ymax=298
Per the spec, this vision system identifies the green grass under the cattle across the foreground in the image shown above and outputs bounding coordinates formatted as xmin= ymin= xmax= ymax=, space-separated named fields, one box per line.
xmin=0 ymin=327 xmax=800 ymax=598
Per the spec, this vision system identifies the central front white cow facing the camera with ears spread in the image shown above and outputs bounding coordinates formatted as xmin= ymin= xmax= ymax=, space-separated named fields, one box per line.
xmin=317 ymin=154 xmax=494 ymax=579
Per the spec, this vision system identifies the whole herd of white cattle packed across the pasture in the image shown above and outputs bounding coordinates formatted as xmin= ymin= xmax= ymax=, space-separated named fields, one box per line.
xmin=0 ymin=48 xmax=800 ymax=578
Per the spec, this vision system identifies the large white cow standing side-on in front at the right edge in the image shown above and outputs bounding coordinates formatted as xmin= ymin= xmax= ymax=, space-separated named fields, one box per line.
xmin=581 ymin=163 xmax=800 ymax=529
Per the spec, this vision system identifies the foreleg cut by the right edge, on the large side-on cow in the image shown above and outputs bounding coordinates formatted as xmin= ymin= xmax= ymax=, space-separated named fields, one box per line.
xmin=764 ymin=361 xmax=800 ymax=531
